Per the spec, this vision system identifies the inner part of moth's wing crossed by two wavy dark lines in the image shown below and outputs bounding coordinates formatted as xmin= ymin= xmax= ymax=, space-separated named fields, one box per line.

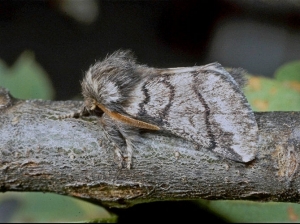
xmin=125 ymin=68 xmax=212 ymax=148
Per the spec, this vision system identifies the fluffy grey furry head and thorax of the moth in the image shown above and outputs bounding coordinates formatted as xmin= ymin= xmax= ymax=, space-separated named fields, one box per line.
xmin=81 ymin=50 xmax=140 ymax=111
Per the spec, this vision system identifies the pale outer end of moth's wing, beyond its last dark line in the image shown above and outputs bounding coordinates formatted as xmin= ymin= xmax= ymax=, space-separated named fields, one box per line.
xmin=195 ymin=63 xmax=258 ymax=162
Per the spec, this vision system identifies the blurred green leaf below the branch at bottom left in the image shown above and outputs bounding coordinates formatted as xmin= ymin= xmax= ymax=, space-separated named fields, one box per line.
xmin=0 ymin=192 xmax=113 ymax=222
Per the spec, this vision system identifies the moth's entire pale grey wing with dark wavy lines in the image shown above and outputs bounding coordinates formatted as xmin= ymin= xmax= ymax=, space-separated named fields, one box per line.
xmin=125 ymin=63 xmax=258 ymax=162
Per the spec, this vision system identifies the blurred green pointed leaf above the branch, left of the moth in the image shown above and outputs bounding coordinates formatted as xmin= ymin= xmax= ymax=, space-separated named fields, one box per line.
xmin=0 ymin=51 xmax=54 ymax=99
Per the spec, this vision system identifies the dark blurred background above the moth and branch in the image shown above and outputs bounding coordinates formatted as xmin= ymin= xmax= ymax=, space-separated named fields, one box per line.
xmin=0 ymin=0 xmax=300 ymax=100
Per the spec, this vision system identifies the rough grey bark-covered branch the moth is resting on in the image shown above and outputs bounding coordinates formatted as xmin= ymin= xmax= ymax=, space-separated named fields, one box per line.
xmin=0 ymin=89 xmax=300 ymax=207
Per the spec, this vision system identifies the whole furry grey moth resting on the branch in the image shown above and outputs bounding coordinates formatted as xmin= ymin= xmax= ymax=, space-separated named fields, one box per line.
xmin=64 ymin=50 xmax=258 ymax=169
